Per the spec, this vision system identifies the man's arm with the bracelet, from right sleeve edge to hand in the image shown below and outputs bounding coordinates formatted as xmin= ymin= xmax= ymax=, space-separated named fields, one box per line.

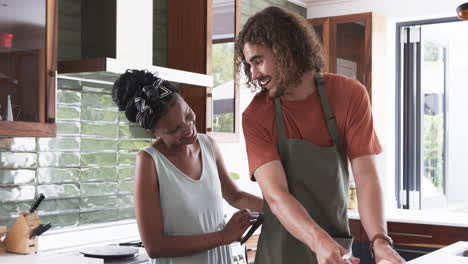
xmin=351 ymin=155 xmax=405 ymax=264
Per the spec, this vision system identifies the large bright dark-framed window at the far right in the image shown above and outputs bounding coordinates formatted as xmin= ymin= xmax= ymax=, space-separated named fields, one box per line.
xmin=395 ymin=18 xmax=468 ymax=213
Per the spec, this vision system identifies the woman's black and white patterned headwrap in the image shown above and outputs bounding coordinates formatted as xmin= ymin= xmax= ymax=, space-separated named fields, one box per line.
xmin=135 ymin=79 xmax=172 ymax=129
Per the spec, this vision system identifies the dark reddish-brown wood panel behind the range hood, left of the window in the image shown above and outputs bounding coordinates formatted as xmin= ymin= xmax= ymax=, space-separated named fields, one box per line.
xmin=167 ymin=0 xmax=207 ymax=133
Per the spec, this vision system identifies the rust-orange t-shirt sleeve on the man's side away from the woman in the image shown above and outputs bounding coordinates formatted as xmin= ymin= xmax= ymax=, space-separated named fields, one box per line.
xmin=346 ymin=82 xmax=382 ymax=160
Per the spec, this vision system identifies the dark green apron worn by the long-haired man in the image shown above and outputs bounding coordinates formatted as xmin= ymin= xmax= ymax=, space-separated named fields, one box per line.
xmin=255 ymin=74 xmax=353 ymax=264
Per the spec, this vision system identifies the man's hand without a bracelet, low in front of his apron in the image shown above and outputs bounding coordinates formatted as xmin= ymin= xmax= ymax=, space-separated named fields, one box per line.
xmin=315 ymin=232 xmax=360 ymax=264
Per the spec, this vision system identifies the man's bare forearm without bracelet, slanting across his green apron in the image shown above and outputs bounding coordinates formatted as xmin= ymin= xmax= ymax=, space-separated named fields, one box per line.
xmin=267 ymin=192 xmax=328 ymax=252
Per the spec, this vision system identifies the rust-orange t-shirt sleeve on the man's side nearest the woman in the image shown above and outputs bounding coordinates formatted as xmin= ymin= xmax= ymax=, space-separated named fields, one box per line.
xmin=242 ymin=113 xmax=280 ymax=181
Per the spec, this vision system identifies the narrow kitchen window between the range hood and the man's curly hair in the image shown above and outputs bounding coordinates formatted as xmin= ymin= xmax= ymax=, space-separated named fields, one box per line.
xmin=207 ymin=0 xmax=241 ymax=143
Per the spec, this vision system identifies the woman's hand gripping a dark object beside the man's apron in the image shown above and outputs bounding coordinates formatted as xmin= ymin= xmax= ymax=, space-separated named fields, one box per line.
xmin=221 ymin=209 xmax=259 ymax=244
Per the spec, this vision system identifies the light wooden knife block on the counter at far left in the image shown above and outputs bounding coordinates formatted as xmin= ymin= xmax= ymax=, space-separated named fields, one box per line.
xmin=5 ymin=213 xmax=41 ymax=254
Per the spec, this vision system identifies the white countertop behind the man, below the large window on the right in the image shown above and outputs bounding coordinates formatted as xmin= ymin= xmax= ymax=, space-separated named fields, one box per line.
xmin=348 ymin=209 xmax=468 ymax=227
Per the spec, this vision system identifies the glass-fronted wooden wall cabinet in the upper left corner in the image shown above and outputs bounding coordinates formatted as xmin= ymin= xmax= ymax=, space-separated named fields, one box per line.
xmin=0 ymin=0 xmax=57 ymax=137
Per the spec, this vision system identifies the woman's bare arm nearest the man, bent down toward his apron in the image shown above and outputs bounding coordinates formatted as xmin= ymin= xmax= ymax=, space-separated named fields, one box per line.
xmin=208 ymin=136 xmax=263 ymax=212
